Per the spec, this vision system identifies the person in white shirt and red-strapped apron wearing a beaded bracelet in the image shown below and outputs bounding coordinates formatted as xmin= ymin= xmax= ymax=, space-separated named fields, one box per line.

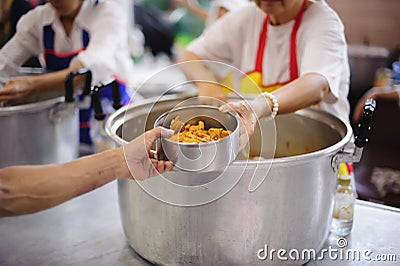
xmin=181 ymin=0 xmax=350 ymax=127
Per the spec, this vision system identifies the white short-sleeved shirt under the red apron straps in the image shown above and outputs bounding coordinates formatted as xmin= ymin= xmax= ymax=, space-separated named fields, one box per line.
xmin=187 ymin=1 xmax=350 ymax=121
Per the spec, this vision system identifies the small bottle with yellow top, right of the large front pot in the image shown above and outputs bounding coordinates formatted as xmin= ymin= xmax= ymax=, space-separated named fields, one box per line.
xmin=331 ymin=163 xmax=356 ymax=236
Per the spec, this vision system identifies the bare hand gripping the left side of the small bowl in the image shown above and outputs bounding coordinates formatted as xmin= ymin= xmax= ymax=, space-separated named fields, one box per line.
xmin=123 ymin=127 xmax=174 ymax=180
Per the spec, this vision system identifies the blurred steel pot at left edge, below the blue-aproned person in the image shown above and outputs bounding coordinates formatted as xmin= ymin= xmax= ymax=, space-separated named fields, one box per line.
xmin=0 ymin=70 xmax=91 ymax=168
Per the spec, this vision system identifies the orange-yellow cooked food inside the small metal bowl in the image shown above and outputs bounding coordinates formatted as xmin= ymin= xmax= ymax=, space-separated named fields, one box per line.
xmin=169 ymin=115 xmax=232 ymax=143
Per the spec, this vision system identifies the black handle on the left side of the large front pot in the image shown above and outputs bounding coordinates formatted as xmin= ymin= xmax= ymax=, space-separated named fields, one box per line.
xmin=91 ymin=80 xmax=122 ymax=121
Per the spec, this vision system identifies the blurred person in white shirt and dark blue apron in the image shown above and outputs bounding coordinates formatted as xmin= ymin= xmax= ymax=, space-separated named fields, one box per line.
xmin=0 ymin=0 xmax=133 ymax=144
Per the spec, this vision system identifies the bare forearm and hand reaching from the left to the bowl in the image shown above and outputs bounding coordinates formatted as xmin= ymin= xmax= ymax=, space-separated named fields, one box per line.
xmin=0 ymin=127 xmax=173 ymax=217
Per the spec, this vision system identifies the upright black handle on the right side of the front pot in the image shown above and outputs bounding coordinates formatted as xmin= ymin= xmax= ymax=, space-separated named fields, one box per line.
xmin=332 ymin=98 xmax=376 ymax=171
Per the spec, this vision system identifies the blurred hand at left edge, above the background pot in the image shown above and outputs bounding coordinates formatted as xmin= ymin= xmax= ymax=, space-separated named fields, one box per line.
xmin=0 ymin=77 xmax=33 ymax=105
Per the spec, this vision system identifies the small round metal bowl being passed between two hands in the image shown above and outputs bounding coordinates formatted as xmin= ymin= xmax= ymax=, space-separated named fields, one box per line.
xmin=154 ymin=105 xmax=239 ymax=172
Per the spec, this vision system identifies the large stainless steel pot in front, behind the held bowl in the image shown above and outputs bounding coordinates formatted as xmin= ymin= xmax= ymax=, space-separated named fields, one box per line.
xmin=106 ymin=97 xmax=372 ymax=265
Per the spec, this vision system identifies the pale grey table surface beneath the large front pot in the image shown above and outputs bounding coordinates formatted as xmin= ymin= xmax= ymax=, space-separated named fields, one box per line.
xmin=0 ymin=182 xmax=400 ymax=266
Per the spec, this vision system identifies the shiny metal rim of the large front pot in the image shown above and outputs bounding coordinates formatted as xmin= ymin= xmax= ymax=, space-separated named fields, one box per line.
xmin=105 ymin=95 xmax=353 ymax=163
